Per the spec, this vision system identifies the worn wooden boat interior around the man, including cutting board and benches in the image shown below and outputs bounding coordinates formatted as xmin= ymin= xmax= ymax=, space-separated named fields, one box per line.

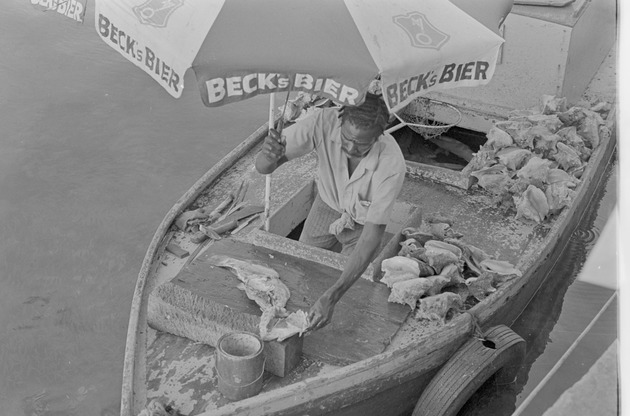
xmin=136 ymin=118 xmax=549 ymax=414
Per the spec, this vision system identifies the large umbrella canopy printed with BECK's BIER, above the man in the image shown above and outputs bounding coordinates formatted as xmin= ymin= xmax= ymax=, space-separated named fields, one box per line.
xmin=95 ymin=0 xmax=503 ymax=112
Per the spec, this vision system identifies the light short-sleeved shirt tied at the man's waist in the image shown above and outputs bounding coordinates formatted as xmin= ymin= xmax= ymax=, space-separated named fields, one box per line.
xmin=282 ymin=108 xmax=406 ymax=224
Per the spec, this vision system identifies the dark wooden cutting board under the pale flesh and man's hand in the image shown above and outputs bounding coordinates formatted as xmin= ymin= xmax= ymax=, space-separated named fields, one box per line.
xmin=149 ymin=239 xmax=410 ymax=364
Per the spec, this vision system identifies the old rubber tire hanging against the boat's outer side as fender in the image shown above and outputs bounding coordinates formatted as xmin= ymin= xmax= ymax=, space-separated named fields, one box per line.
xmin=413 ymin=325 xmax=525 ymax=416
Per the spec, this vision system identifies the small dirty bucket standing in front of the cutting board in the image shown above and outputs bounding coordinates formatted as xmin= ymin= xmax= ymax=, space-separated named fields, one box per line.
xmin=215 ymin=332 xmax=265 ymax=400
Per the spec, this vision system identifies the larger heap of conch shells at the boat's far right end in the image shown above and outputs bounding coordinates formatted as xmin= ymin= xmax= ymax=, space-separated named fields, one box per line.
xmin=462 ymin=95 xmax=611 ymax=223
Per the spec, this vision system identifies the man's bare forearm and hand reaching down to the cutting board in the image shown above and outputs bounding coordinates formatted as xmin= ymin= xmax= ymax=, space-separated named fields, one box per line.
xmin=308 ymin=222 xmax=385 ymax=330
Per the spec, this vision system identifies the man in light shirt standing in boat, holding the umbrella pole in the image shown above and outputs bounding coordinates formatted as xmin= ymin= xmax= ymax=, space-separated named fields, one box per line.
xmin=255 ymin=94 xmax=405 ymax=330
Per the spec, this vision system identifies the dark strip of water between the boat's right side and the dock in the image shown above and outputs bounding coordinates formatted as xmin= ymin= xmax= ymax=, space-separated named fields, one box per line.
xmin=458 ymin=156 xmax=617 ymax=416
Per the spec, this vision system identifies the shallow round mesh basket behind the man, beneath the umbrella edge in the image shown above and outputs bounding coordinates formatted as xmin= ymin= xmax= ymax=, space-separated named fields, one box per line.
xmin=392 ymin=98 xmax=462 ymax=139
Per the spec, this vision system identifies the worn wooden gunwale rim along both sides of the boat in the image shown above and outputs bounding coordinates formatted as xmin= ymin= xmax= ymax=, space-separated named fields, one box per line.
xmin=121 ymin=105 xmax=616 ymax=416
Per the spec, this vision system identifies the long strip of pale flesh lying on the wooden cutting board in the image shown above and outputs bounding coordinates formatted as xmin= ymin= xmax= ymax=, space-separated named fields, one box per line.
xmin=208 ymin=255 xmax=308 ymax=342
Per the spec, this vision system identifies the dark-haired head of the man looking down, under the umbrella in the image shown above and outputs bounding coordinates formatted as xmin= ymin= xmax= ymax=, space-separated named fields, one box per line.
xmin=339 ymin=94 xmax=389 ymax=158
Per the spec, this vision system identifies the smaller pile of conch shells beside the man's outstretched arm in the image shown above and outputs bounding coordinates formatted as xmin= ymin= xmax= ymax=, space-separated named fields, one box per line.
xmin=381 ymin=217 xmax=522 ymax=323
